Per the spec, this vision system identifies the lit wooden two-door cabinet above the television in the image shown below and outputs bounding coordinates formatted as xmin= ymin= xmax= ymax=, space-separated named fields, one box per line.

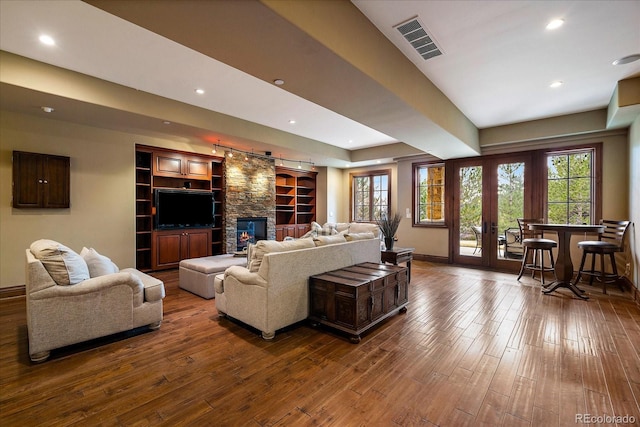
xmin=153 ymin=151 xmax=211 ymax=181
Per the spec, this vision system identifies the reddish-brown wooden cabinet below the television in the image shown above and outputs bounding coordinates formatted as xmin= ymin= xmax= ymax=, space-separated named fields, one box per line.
xmin=152 ymin=228 xmax=211 ymax=270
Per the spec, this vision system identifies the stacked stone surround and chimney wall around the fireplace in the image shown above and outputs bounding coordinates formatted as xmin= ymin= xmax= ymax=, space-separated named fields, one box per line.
xmin=224 ymin=153 xmax=276 ymax=253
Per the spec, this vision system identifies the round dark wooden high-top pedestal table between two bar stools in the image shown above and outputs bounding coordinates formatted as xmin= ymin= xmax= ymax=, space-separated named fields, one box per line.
xmin=529 ymin=224 xmax=604 ymax=299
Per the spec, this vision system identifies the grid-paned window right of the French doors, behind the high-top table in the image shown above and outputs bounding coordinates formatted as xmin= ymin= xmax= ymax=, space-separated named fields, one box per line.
xmin=547 ymin=149 xmax=596 ymax=224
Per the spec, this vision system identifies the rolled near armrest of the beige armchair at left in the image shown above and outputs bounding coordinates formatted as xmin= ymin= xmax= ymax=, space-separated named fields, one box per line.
xmin=29 ymin=272 xmax=144 ymax=306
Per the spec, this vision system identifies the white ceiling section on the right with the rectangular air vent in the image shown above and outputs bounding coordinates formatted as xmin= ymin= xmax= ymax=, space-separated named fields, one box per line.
xmin=352 ymin=0 xmax=640 ymax=129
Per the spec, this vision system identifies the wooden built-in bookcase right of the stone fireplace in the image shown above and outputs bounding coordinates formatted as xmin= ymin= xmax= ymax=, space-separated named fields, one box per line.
xmin=276 ymin=167 xmax=317 ymax=240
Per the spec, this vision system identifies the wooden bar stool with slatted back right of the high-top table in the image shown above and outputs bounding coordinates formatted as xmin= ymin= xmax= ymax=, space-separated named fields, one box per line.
xmin=573 ymin=220 xmax=631 ymax=294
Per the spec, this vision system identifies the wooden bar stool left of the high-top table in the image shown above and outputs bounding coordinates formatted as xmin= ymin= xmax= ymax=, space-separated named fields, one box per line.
xmin=516 ymin=218 xmax=558 ymax=285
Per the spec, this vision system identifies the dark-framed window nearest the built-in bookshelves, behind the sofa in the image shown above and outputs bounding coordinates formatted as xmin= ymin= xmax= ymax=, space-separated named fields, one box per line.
xmin=351 ymin=171 xmax=391 ymax=222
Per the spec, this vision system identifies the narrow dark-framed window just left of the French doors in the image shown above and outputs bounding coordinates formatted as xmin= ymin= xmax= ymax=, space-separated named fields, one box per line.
xmin=413 ymin=164 xmax=445 ymax=225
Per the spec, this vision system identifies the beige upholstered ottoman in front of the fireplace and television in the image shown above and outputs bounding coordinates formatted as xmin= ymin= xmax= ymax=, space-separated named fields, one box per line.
xmin=179 ymin=254 xmax=247 ymax=299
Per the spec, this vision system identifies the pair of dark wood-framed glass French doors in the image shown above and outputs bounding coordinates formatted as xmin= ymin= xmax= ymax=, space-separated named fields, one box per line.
xmin=450 ymin=154 xmax=533 ymax=271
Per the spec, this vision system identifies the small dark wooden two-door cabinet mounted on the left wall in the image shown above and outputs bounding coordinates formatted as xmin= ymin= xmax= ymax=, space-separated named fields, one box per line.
xmin=13 ymin=151 xmax=71 ymax=208
